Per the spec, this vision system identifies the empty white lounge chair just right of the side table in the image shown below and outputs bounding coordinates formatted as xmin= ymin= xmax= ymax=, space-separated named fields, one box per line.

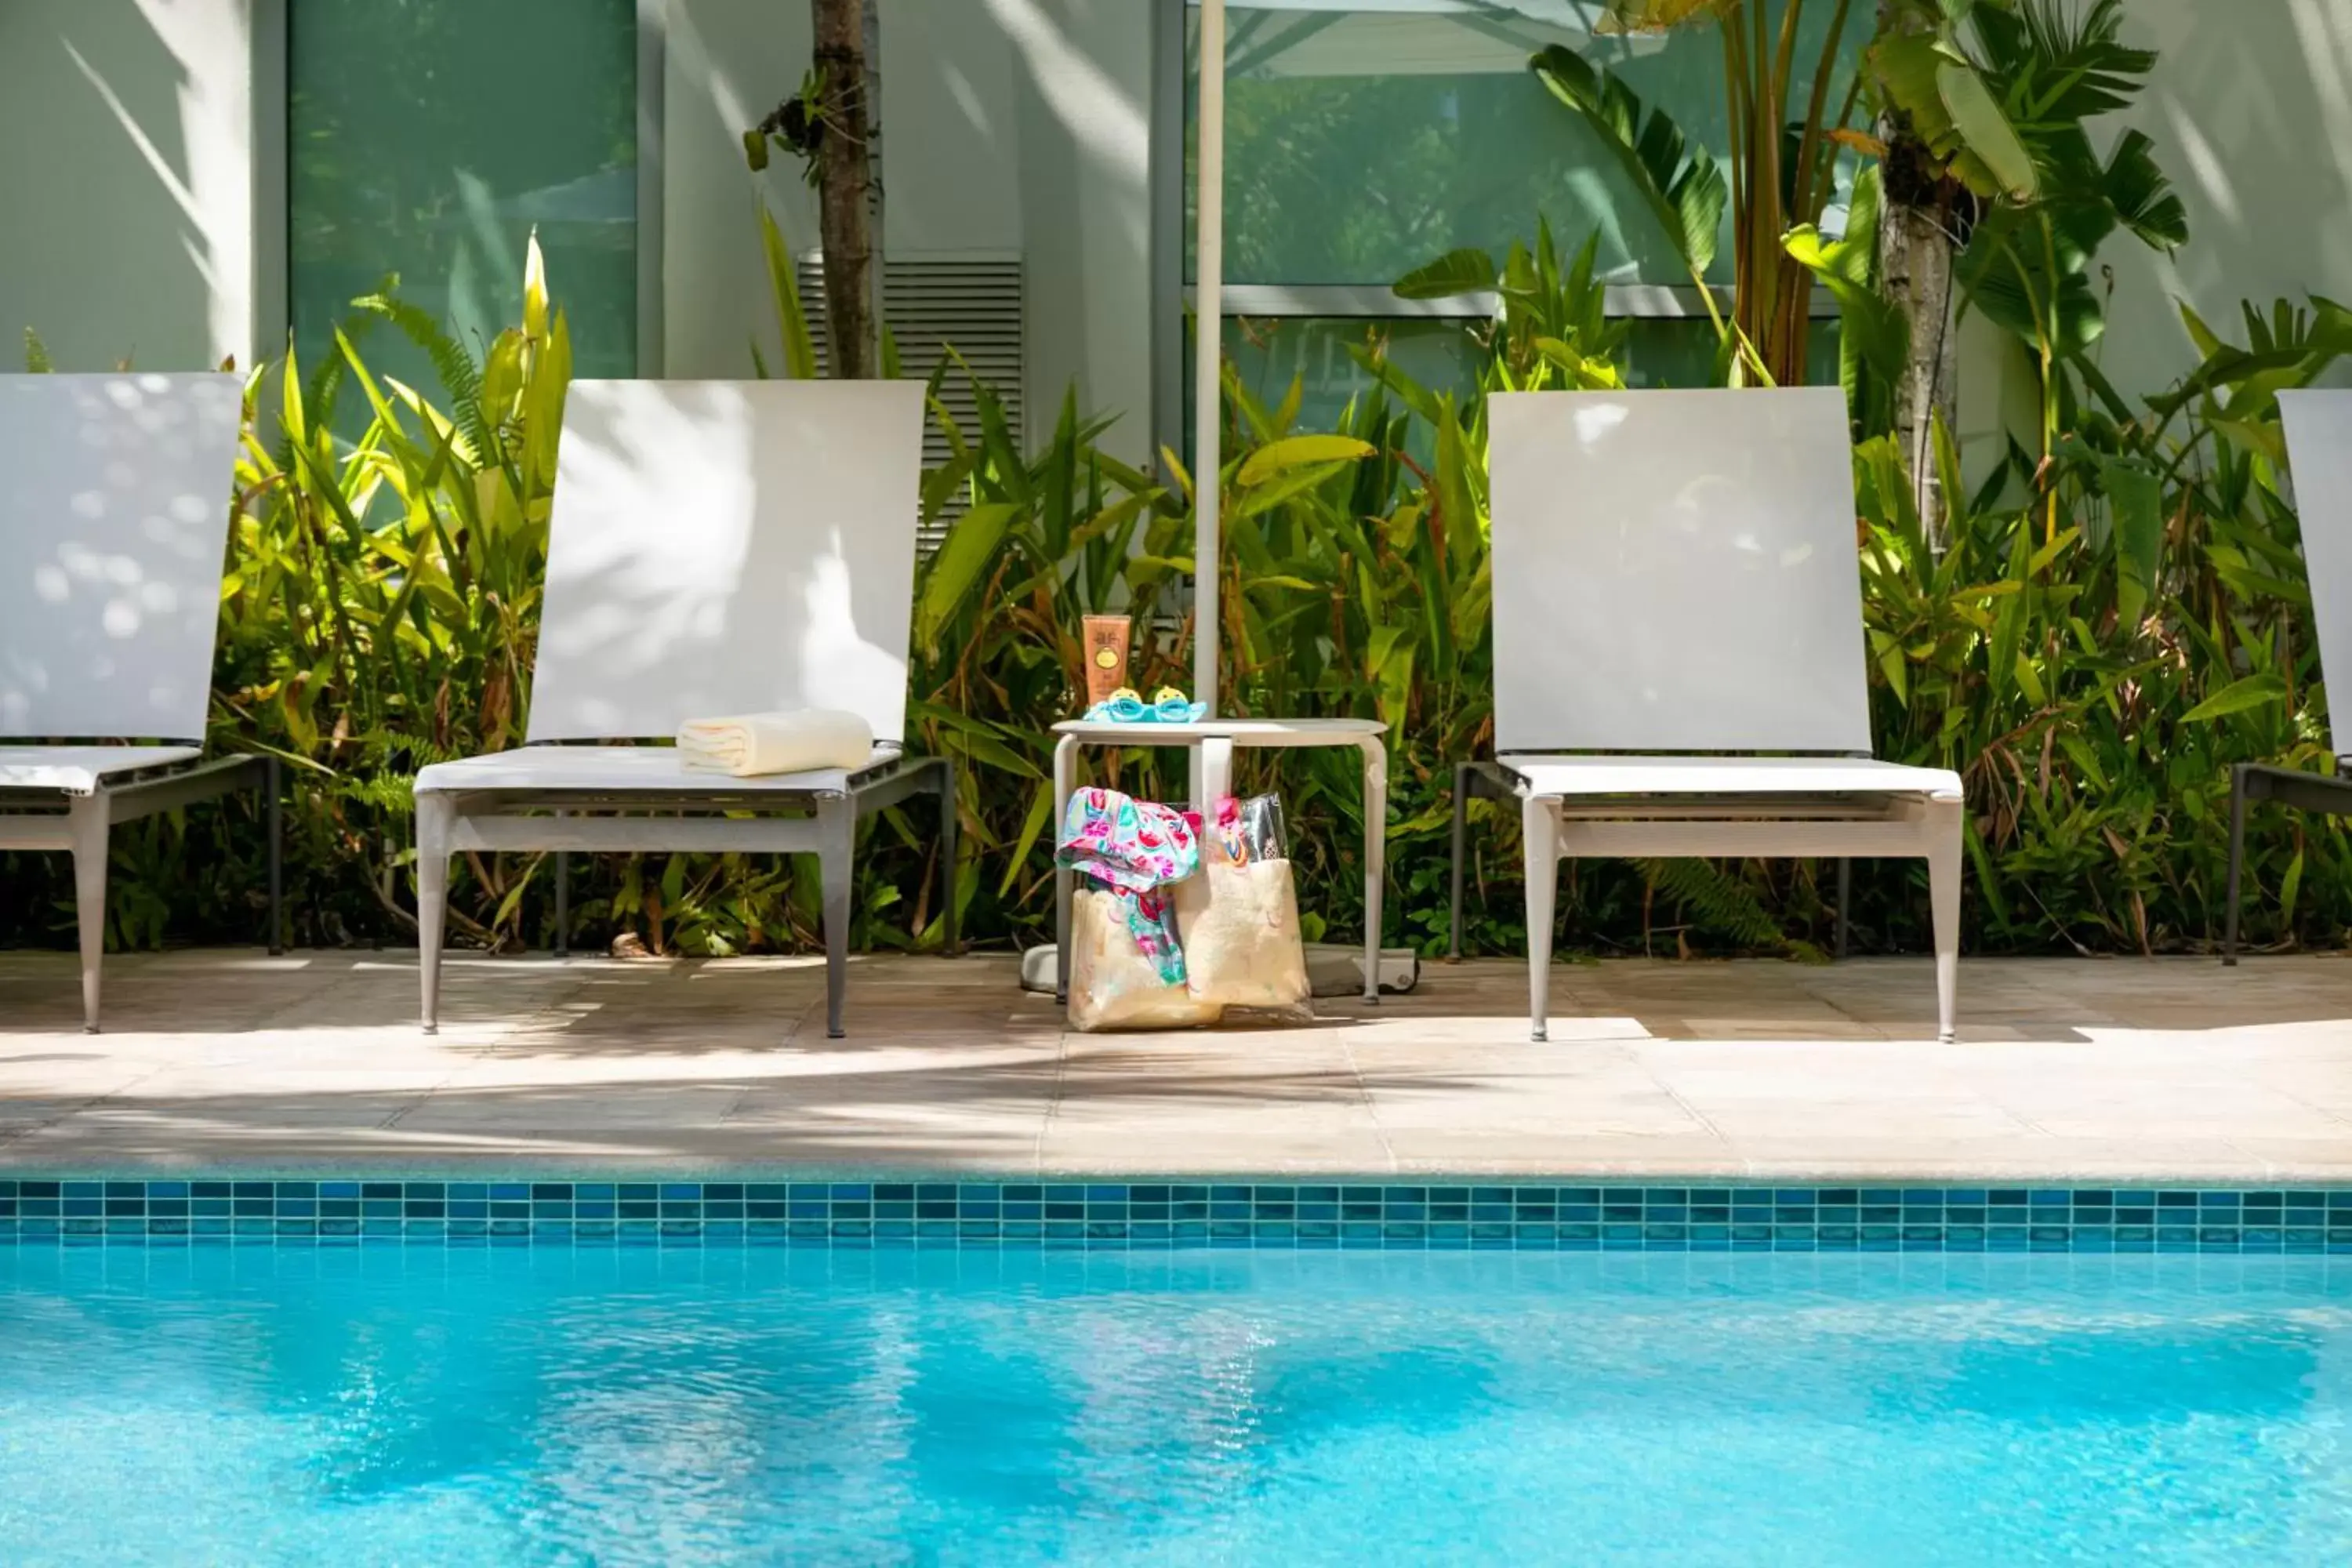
xmin=1456 ymin=388 xmax=1962 ymax=1039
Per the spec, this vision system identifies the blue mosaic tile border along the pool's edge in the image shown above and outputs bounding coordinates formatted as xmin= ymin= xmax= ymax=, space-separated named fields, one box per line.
xmin=0 ymin=1175 xmax=2352 ymax=1255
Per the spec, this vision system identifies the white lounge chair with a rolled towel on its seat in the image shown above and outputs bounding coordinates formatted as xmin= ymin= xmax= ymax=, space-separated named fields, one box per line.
xmin=416 ymin=381 xmax=955 ymax=1036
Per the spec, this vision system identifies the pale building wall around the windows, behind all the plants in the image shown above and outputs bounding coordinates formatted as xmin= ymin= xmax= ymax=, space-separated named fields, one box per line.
xmin=0 ymin=0 xmax=2352 ymax=459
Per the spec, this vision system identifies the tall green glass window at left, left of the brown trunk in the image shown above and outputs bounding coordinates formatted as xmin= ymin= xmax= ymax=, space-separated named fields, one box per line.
xmin=287 ymin=0 xmax=637 ymax=388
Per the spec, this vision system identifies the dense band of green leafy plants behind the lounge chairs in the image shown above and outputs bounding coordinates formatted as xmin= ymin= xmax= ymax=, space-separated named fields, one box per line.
xmin=7 ymin=208 xmax=2352 ymax=956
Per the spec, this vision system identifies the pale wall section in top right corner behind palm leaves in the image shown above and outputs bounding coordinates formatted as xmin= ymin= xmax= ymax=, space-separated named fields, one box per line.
xmin=2105 ymin=0 xmax=2352 ymax=393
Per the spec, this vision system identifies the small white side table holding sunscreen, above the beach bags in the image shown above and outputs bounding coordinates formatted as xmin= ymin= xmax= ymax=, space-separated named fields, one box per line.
xmin=1051 ymin=720 xmax=1388 ymax=1004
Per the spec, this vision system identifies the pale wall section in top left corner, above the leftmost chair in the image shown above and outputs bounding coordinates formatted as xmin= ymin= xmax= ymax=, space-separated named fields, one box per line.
xmin=0 ymin=0 xmax=252 ymax=372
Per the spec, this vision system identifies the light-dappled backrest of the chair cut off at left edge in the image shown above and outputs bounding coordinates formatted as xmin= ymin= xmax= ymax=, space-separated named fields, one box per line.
xmin=0 ymin=372 xmax=242 ymax=741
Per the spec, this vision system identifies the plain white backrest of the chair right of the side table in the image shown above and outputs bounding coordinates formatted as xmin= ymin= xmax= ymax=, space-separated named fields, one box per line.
xmin=1486 ymin=388 xmax=1870 ymax=755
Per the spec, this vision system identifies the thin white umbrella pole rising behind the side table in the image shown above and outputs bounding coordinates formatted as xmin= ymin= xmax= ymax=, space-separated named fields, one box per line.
xmin=1192 ymin=0 xmax=1225 ymax=720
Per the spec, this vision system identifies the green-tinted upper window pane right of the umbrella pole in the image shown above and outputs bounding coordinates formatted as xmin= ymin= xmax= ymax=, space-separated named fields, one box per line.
xmin=1185 ymin=0 xmax=1875 ymax=287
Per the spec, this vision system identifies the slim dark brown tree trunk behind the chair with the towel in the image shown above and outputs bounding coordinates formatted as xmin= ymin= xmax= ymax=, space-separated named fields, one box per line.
xmin=809 ymin=0 xmax=877 ymax=381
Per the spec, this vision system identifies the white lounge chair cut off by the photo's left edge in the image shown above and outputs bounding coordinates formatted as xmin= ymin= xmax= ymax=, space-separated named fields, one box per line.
xmin=0 ymin=374 xmax=280 ymax=1034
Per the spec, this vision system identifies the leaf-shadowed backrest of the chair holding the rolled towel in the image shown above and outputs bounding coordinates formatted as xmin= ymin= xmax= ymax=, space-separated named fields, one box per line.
xmin=527 ymin=381 xmax=922 ymax=741
